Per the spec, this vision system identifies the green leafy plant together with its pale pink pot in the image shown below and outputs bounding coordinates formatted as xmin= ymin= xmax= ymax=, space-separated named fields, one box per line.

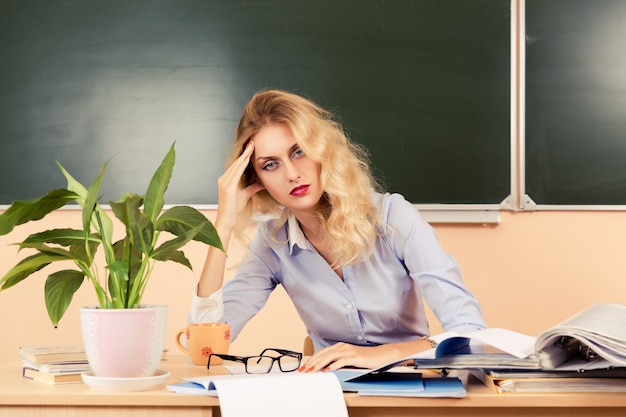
xmin=0 ymin=144 xmax=224 ymax=377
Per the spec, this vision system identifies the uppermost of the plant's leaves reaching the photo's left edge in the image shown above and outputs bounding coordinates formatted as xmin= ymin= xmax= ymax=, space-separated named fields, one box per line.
xmin=0 ymin=188 xmax=80 ymax=235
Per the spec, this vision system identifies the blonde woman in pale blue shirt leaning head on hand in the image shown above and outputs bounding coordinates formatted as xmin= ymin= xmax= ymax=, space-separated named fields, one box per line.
xmin=190 ymin=90 xmax=485 ymax=371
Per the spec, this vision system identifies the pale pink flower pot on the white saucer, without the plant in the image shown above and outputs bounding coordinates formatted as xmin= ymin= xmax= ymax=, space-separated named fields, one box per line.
xmin=80 ymin=305 xmax=167 ymax=378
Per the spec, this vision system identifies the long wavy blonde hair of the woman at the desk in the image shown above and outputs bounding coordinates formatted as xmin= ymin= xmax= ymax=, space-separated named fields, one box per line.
xmin=228 ymin=90 xmax=380 ymax=267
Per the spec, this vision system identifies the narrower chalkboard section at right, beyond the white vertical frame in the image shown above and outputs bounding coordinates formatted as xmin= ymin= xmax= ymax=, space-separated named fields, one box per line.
xmin=525 ymin=0 xmax=626 ymax=206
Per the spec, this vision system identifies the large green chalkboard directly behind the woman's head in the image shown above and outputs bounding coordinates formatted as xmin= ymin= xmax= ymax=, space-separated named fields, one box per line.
xmin=0 ymin=0 xmax=511 ymax=205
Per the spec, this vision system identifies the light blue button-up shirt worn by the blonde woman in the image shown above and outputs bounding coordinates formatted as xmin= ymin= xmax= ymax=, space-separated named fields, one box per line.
xmin=190 ymin=194 xmax=486 ymax=349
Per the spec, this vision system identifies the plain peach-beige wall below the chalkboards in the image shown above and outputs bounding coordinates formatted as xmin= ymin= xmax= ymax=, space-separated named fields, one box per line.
xmin=0 ymin=211 xmax=626 ymax=360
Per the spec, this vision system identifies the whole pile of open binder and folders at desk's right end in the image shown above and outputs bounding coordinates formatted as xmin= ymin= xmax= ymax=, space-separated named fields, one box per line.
xmin=366 ymin=303 xmax=626 ymax=393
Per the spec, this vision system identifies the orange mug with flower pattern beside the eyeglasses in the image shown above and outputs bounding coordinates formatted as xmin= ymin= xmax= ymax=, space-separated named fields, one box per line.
xmin=175 ymin=323 xmax=230 ymax=366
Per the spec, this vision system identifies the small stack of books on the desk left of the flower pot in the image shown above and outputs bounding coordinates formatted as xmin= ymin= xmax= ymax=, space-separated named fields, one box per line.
xmin=19 ymin=346 xmax=90 ymax=384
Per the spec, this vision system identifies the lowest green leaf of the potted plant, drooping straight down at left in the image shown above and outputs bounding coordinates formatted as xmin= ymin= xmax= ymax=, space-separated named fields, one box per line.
xmin=44 ymin=270 xmax=85 ymax=327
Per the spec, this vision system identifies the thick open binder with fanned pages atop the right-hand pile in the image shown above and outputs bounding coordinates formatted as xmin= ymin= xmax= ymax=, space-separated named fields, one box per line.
xmin=371 ymin=303 xmax=626 ymax=372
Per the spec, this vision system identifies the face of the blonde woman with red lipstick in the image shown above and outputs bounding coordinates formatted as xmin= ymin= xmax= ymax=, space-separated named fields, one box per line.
xmin=250 ymin=124 xmax=323 ymax=216
